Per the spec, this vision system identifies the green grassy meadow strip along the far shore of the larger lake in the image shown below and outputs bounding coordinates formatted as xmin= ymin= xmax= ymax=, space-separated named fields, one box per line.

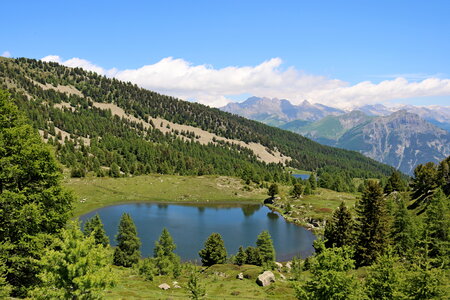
xmin=64 ymin=175 xmax=267 ymax=216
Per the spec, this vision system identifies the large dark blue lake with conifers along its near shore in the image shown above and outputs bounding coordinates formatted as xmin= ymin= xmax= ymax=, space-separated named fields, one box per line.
xmin=80 ymin=203 xmax=315 ymax=261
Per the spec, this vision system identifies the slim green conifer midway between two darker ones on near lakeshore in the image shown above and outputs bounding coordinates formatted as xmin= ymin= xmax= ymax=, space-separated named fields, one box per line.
xmin=153 ymin=228 xmax=181 ymax=277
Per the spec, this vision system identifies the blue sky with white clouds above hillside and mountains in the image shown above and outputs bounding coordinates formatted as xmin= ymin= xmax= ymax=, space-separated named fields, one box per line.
xmin=0 ymin=0 xmax=450 ymax=108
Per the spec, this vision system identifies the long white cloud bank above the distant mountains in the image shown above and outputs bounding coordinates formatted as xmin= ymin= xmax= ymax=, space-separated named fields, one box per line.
xmin=42 ymin=55 xmax=450 ymax=108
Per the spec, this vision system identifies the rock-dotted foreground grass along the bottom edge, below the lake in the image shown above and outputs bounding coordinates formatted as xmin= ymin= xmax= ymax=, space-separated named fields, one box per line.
xmin=105 ymin=264 xmax=295 ymax=299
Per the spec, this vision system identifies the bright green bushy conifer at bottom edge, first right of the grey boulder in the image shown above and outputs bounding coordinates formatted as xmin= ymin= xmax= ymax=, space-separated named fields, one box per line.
xmin=294 ymin=247 xmax=362 ymax=300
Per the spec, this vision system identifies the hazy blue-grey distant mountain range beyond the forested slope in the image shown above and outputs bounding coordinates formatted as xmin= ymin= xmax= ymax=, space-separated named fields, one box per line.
xmin=222 ymin=97 xmax=450 ymax=174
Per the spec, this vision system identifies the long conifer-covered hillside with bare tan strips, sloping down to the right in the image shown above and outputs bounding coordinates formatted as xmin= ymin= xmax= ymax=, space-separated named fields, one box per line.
xmin=0 ymin=58 xmax=391 ymax=182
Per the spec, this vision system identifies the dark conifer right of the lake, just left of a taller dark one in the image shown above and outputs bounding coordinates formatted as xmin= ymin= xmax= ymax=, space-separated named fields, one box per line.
xmin=324 ymin=202 xmax=354 ymax=248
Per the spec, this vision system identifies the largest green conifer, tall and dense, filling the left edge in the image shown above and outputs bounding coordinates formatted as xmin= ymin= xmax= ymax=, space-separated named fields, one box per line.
xmin=0 ymin=90 xmax=73 ymax=296
